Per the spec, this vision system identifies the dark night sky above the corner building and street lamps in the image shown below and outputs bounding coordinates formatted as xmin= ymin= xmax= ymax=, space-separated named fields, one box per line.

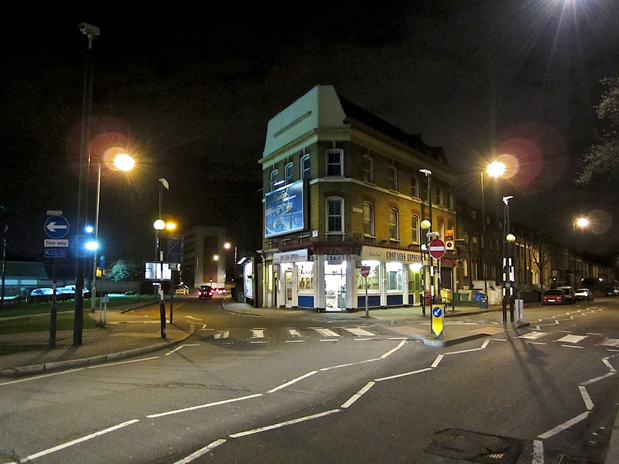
xmin=0 ymin=0 xmax=619 ymax=262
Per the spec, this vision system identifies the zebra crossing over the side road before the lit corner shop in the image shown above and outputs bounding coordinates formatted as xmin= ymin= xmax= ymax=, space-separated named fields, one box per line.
xmin=199 ymin=325 xmax=403 ymax=344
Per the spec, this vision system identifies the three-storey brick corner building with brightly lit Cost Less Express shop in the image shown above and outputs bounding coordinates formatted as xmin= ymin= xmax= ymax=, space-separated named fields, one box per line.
xmin=259 ymin=86 xmax=456 ymax=311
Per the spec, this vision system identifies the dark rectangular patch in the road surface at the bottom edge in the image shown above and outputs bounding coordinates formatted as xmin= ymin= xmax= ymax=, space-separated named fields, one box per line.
xmin=425 ymin=429 xmax=523 ymax=464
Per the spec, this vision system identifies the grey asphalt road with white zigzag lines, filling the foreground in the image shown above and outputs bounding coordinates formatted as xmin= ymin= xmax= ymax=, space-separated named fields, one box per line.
xmin=0 ymin=298 xmax=619 ymax=464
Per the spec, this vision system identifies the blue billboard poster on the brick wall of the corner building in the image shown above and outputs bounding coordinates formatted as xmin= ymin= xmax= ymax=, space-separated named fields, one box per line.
xmin=264 ymin=180 xmax=305 ymax=238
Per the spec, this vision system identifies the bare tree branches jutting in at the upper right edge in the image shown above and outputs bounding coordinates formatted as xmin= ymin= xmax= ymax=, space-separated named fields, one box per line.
xmin=575 ymin=77 xmax=619 ymax=185
